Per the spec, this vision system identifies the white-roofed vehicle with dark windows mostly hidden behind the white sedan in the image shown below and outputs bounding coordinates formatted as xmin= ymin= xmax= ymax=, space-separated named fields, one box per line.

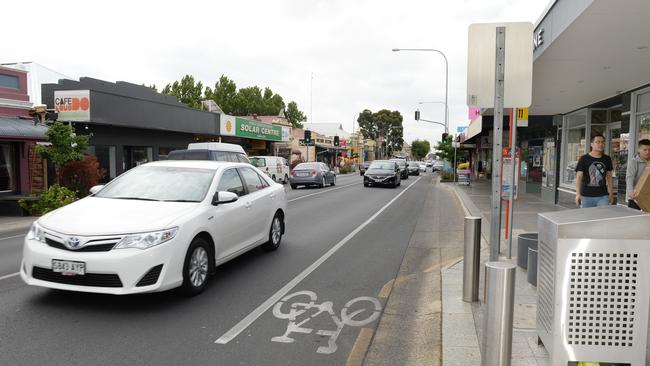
xmin=167 ymin=142 xmax=250 ymax=164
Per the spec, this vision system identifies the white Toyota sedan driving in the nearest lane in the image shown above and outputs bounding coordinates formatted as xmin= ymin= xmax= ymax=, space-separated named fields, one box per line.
xmin=20 ymin=160 xmax=287 ymax=295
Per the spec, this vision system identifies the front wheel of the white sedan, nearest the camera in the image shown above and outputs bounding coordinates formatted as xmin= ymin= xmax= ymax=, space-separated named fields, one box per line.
xmin=181 ymin=238 xmax=214 ymax=296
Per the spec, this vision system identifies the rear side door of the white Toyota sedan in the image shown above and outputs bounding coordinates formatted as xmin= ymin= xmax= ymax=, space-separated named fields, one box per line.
xmin=237 ymin=167 xmax=273 ymax=245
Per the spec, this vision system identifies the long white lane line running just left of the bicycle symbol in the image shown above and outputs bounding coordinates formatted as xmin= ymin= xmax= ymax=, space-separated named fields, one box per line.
xmin=214 ymin=178 xmax=422 ymax=344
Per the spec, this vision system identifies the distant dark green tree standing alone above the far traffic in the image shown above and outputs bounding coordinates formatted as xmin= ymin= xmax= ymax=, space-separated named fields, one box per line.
xmin=357 ymin=109 xmax=404 ymax=155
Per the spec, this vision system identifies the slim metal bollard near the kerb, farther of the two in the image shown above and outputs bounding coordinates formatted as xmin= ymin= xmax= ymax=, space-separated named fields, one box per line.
xmin=463 ymin=216 xmax=481 ymax=302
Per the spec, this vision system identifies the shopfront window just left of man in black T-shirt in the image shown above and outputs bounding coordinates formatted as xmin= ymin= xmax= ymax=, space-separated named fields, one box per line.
xmin=561 ymin=110 xmax=587 ymax=185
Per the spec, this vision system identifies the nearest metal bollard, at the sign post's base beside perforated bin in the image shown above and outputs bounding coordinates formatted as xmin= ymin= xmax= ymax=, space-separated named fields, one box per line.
xmin=481 ymin=262 xmax=517 ymax=366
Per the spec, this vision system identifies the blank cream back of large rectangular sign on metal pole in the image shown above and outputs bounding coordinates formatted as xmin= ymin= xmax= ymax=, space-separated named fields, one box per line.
xmin=467 ymin=22 xmax=534 ymax=108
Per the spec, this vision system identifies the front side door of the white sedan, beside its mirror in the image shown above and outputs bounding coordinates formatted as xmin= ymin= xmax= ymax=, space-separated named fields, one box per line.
xmin=212 ymin=168 xmax=252 ymax=260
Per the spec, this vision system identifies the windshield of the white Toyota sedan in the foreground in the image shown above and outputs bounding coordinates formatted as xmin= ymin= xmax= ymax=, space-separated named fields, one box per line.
xmin=94 ymin=166 xmax=215 ymax=202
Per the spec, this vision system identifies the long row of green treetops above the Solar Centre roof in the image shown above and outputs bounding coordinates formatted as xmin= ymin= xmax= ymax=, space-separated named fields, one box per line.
xmin=162 ymin=75 xmax=307 ymax=127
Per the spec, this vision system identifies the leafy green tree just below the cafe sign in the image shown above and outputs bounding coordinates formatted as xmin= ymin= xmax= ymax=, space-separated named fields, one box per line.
xmin=36 ymin=121 xmax=90 ymax=166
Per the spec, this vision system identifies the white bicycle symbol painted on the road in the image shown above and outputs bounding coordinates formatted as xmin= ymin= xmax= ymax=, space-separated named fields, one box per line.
xmin=271 ymin=291 xmax=381 ymax=354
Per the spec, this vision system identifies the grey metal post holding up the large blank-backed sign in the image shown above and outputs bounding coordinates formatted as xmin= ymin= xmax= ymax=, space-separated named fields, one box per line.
xmin=490 ymin=27 xmax=506 ymax=261
